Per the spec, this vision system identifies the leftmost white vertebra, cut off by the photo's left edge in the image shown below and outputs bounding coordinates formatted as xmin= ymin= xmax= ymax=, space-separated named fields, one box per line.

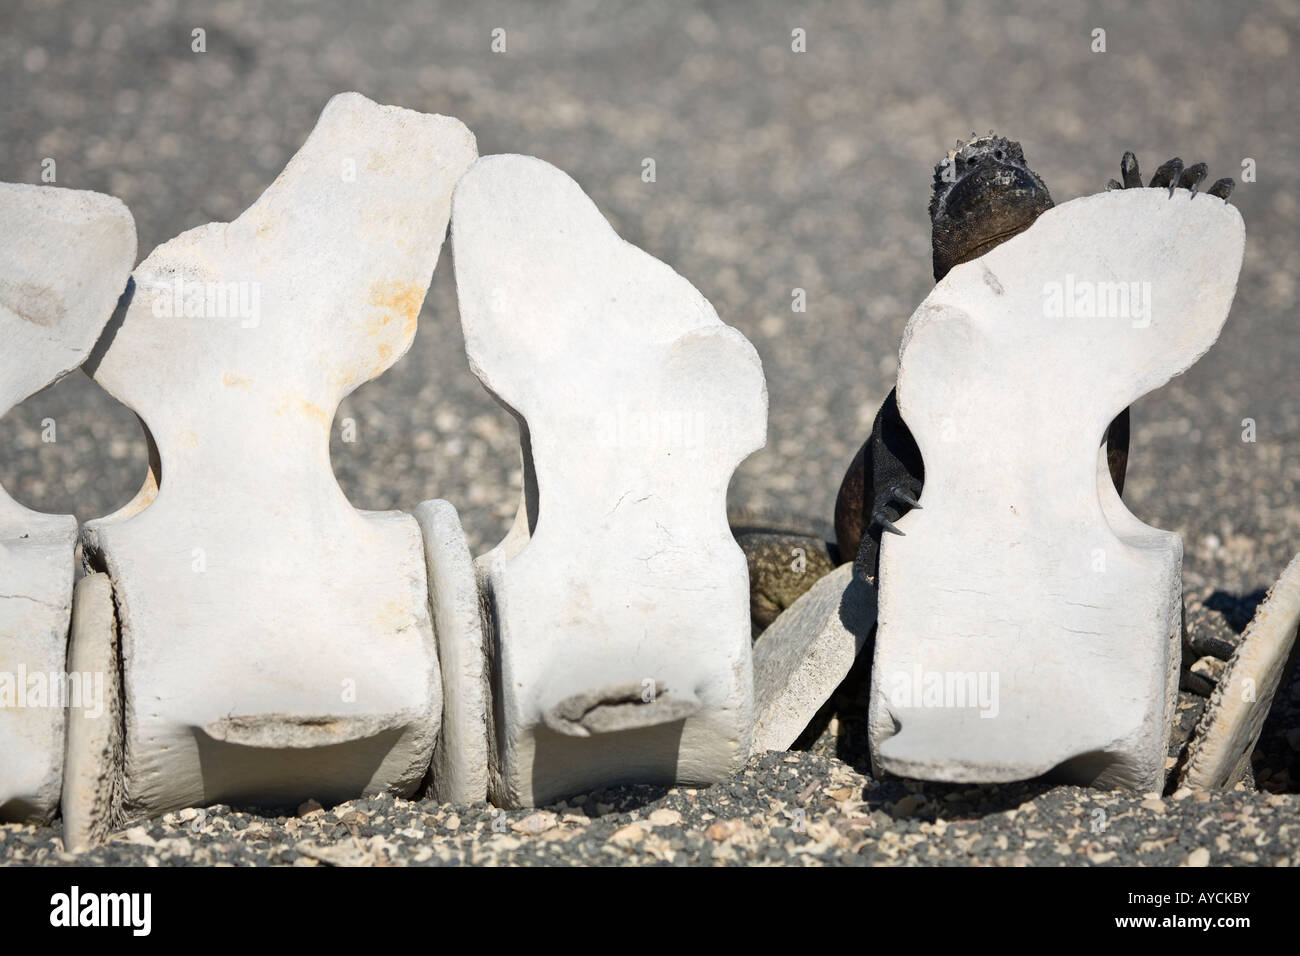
xmin=0 ymin=183 xmax=135 ymax=821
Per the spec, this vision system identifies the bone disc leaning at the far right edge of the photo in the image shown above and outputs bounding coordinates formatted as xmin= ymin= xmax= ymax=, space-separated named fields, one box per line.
xmin=1178 ymin=554 xmax=1300 ymax=790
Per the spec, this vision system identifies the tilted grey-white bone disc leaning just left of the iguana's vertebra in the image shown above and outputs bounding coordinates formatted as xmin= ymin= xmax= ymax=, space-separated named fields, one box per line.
xmin=750 ymin=563 xmax=876 ymax=753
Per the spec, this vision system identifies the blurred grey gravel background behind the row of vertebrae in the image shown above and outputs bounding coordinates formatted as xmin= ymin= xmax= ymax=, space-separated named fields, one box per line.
xmin=0 ymin=0 xmax=1300 ymax=606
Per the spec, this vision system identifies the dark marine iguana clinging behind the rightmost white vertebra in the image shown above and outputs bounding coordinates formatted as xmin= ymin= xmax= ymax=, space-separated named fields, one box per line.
xmin=729 ymin=130 xmax=1235 ymax=633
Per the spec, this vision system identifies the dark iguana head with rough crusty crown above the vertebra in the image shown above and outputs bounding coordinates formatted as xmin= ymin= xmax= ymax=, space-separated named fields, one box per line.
xmin=930 ymin=130 xmax=1052 ymax=282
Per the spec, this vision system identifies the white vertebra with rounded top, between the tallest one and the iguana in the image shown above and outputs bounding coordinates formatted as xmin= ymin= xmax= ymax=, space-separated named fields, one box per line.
xmin=451 ymin=156 xmax=767 ymax=806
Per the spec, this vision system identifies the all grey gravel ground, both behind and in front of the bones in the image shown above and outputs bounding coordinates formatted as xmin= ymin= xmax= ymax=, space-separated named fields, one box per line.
xmin=0 ymin=0 xmax=1300 ymax=865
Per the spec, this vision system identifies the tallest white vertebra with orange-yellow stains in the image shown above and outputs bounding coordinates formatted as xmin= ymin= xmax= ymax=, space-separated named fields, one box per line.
xmin=68 ymin=94 xmax=476 ymax=832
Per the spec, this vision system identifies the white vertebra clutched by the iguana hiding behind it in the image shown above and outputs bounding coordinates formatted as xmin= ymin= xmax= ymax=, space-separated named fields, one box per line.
xmin=870 ymin=189 xmax=1244 ymax=791
